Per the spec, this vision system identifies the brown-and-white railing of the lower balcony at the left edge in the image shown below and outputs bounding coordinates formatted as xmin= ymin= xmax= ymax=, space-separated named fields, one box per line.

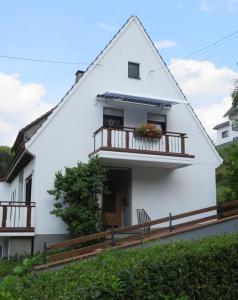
xmin=0 ymin=201 xmax=35 ymax=232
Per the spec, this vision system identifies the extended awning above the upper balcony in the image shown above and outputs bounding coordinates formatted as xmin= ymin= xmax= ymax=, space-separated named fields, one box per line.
xmin=97 ymin=92 xmax=182 ymax=108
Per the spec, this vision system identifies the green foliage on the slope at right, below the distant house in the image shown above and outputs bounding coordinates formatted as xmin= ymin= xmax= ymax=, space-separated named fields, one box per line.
xmin=216 ymin=142 xmax=238 ymax=203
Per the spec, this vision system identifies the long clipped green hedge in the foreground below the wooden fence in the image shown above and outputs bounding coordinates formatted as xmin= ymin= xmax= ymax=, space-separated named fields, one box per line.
xmin=4 ymin=234 xmax=238 ymax=300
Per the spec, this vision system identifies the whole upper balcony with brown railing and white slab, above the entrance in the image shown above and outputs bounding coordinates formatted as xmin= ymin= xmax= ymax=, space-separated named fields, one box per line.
xmin=90 ymin=127 xmax=194 ymax=168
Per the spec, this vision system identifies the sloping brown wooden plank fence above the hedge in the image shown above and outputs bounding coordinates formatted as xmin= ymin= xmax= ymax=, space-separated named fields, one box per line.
xmin=44 ymin=200 xmax=238 ymax=262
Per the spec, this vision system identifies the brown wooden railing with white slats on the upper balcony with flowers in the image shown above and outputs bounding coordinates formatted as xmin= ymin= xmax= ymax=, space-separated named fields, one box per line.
xmin=92 ymin=127 xmax=194 ymax=158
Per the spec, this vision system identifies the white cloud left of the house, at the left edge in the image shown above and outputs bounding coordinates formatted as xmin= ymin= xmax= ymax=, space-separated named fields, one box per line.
xmin=0 ymin=73 xmax=52 ymax=145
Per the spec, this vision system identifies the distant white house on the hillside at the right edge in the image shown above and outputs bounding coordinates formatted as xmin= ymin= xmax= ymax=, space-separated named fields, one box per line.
xmin=213 ymin=106 xmax=238 ymax=146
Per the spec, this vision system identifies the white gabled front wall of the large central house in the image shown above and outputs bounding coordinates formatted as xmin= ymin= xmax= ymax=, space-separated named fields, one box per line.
xmin=0 ymin=17 xmax=221 ymax=253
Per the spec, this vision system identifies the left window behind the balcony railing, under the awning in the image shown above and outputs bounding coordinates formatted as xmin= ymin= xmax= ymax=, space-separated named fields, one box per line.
xmin=103 ymin=107 xmax=124 ymax=128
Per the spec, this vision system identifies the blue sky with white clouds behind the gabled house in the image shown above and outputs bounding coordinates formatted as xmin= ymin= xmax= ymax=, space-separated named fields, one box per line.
xmin=0 ymin=0 xmax=238 ymax=146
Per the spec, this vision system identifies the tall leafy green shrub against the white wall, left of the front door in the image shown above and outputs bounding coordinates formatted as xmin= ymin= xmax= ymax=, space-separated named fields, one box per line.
xmin=48 ymin=157 xmax=107 ymax=236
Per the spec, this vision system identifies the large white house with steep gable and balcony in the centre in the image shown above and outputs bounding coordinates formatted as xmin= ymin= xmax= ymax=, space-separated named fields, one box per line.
xmin=0 ymin=16 xmax=222 ymax=255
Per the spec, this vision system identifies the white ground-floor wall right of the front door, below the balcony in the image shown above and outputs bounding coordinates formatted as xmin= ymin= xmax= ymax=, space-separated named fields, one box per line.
xmin=132 ymin=165 xmax=216 ymax=223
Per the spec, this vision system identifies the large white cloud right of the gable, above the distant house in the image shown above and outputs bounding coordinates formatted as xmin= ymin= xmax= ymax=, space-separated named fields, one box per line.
xmin=170 ymin=59 xmax=238 ymax=138
